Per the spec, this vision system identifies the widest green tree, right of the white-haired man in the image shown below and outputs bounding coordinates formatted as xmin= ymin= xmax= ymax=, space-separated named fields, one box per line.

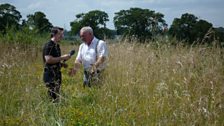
xmin=114 ymin=8 xmax=167 ymax=42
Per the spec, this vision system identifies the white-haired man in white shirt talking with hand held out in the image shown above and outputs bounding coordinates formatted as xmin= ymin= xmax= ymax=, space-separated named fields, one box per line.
xmin=69 ymin=26 xmax=108 ymax=87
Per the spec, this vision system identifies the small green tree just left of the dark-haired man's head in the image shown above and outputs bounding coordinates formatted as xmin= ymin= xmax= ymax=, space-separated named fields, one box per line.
xmin=23 ymin=11 xmax=53 ymax=34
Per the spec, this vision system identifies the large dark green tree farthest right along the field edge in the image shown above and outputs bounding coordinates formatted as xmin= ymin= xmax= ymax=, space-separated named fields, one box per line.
xmin=169 ymin=13 xmax=212 ymax=44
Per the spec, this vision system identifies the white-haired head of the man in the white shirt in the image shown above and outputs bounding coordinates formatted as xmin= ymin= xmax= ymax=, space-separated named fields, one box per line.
xmin=80 ymin=26 xmax=94 ymax=44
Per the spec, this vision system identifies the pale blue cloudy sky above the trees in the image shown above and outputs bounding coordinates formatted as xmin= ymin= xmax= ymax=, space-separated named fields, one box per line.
xmin=0 ymin=0 xmax=224 ymax=30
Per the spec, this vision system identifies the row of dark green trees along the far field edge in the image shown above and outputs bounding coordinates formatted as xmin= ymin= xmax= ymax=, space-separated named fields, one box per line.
xmin=0 ymin=3 xmax=224 ymax=44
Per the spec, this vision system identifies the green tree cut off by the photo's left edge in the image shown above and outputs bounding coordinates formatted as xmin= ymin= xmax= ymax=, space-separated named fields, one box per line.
xmin=0 ymin=3 xmax=22 ymax=33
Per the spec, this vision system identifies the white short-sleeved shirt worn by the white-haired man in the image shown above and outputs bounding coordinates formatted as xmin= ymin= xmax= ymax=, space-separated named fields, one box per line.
xmin=76 ymin=37 xmax=108 ymax=70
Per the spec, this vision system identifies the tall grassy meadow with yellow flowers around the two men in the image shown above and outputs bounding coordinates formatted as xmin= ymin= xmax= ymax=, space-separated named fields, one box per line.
xmin=0 ymin=40 xmax=224 ymax=126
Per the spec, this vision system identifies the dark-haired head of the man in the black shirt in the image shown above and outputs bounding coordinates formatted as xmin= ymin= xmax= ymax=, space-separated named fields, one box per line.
xmin=51 ymin=27 xmax=64 ymax=42
